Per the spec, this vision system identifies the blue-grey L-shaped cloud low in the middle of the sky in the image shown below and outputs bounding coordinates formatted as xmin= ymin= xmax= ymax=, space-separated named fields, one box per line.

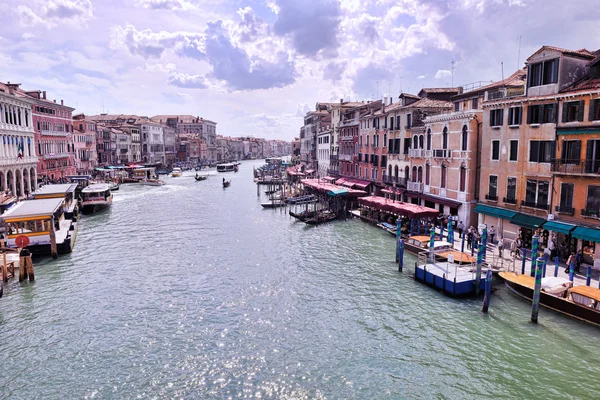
xmin=204 ymin=21 xmax=295 ymax=90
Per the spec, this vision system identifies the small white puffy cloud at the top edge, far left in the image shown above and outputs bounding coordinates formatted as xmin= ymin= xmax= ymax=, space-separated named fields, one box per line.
xmin=17 ymin=0 xmax=94 ymax=28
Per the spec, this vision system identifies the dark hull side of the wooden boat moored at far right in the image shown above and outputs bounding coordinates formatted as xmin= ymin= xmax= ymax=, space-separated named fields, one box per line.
xmin=500 ymin=274 xmax=600 ymax=326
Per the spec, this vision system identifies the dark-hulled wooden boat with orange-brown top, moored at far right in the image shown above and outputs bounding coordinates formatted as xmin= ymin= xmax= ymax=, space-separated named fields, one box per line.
xmin=499 ymin=272 xmax=600 ymax=326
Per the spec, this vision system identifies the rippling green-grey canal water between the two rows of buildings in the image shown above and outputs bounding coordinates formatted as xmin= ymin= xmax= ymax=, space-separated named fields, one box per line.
xmin=0 ymin=162 xmax=600 ymax=399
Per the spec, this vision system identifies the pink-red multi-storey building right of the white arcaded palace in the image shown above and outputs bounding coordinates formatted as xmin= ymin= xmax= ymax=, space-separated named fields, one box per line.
xmin=24 ymin=90 xmax=76 ymax=180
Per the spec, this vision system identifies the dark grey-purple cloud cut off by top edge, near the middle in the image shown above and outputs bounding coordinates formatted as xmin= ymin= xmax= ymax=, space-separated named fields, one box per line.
xmin=273 ymin=0 xmax=341 ymax=58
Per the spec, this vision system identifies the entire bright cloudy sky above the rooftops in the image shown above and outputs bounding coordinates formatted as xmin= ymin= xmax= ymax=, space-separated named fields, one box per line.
xmin=0 ymin=0 xmax=600 ymax=140
